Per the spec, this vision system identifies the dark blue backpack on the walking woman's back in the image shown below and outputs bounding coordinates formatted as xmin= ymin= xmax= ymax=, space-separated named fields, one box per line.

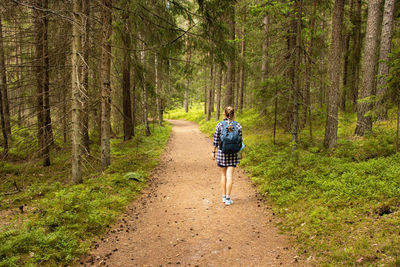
xmin=219 ymin=121 xmax=242 ymax=154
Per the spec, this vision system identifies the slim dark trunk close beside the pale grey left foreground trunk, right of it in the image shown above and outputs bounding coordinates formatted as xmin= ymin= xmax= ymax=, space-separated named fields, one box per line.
xmin=81 ymin=0 xmax=90 ymax=154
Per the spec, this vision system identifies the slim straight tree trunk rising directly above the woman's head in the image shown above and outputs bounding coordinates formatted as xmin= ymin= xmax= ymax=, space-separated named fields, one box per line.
xmin=225 ymin=5 xmax=235 ymax=106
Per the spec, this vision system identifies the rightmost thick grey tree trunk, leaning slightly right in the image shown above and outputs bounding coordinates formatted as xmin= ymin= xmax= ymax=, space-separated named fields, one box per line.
xmin=376 ymin=0 xmax=394 ymax=120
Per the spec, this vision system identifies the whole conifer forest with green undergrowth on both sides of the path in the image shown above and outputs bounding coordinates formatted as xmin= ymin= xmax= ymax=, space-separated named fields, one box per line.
xmin=0 ymin=0 xmax=400 ymax=266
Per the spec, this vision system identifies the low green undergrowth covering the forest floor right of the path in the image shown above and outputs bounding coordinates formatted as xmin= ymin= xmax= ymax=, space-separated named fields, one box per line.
xmin=169 ymin=106 xmax=400 ymax=266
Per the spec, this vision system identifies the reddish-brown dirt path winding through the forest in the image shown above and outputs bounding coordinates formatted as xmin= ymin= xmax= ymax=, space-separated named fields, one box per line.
xmin=80 ymin=121 xmax=303 ymax=266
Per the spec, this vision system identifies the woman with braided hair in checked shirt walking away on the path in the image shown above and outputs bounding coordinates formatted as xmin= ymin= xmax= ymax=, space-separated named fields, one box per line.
xmin=212 ymin=106 xmax=243 ymax=205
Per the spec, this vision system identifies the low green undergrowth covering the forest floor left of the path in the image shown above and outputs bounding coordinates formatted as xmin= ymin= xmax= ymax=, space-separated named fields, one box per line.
xmin=0 ymin=123 xmax=171 ymax=266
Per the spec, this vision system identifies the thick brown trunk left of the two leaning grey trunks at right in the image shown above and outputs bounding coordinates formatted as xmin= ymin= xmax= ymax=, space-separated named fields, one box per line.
xmin=324 ymin=0 xmax=345 ymax=148
